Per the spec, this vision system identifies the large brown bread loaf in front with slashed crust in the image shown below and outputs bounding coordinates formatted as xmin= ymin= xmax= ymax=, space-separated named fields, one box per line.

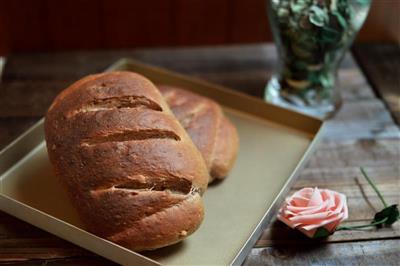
xmin=45 ymin=72 xmax=209 ymax=251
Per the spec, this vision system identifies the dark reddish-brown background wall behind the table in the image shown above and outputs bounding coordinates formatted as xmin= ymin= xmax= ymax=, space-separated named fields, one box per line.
xmin=0 ymin=0 xmax=400 ymax=55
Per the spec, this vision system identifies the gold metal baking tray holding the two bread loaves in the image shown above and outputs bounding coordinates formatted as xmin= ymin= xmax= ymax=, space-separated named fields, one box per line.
xmin=0 ymin=59 xmax=322 ymax=265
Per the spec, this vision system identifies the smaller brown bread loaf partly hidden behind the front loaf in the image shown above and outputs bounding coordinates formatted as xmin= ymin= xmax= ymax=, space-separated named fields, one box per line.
xmin=158 ymin=85 xmax=239 ymax=182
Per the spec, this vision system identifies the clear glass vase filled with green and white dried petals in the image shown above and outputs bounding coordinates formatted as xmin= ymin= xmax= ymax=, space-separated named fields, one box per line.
xmin=265 ymin=0 xmax=371 ymax=119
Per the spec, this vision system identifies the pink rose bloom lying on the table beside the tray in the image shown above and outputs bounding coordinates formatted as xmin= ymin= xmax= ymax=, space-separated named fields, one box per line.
xmin=278 ymin=188 xmax=348 ymax=237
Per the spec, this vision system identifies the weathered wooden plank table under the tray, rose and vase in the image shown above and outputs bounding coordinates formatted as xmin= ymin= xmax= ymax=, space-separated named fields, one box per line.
xmin=0 ymin=45 xmax=400 ymax=265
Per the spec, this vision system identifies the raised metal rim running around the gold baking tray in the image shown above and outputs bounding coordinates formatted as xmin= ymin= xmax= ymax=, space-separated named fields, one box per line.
xmin=0 ymin=58 xmax=325 ymax=265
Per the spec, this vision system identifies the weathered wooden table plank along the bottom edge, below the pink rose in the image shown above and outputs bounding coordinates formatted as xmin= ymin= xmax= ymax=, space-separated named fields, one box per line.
xmin=244 ymin=239 xmax=400 ymax=266
